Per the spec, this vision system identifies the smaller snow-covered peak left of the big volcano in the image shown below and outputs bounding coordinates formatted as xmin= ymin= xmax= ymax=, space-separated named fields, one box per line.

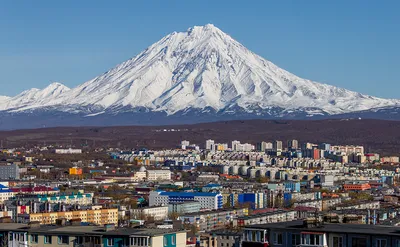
xmin=0 ymin=82 xmax=70 ymax=110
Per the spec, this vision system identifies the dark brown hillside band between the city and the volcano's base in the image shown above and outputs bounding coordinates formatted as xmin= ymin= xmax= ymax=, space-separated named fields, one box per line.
xmin=0 ymin=120 xmax=400 ymax=154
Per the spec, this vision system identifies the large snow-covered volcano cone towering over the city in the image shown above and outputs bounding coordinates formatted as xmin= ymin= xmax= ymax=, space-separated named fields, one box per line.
xmin=0 ymin=24 xmax=400 ymax=114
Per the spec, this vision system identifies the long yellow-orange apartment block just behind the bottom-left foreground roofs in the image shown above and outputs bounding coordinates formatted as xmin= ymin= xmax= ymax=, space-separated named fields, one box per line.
xmin=29 ymin=208 xmax=118 ymax=225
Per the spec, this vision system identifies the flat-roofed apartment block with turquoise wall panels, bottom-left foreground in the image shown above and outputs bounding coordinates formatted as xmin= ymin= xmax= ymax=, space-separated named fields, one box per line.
xmin=0 ymin=223 xmax=186 ymax=247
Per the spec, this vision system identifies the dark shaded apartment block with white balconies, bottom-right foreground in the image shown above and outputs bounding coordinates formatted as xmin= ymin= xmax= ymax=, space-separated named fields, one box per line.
xmin=242 ymin=221 xmax=400 ymax=247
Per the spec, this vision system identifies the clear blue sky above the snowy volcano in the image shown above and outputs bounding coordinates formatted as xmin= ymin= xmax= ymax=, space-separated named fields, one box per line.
xmin=0 ymin=0 xmax=400 ymax=98
